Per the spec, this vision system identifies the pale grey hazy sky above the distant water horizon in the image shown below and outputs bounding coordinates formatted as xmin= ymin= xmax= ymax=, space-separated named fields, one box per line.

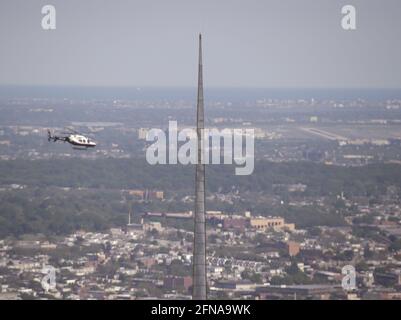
xmin=0 ymin=0 xmax=401 ymax=87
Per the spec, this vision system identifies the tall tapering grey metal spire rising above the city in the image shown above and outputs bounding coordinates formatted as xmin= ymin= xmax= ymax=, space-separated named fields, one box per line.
xmin=192 ymin=34 xmax=207 ymax=300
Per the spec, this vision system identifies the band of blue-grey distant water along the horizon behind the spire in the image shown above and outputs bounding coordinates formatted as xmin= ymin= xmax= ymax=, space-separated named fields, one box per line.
xmin=0 ymin=86 xmax=401 ymax=102
